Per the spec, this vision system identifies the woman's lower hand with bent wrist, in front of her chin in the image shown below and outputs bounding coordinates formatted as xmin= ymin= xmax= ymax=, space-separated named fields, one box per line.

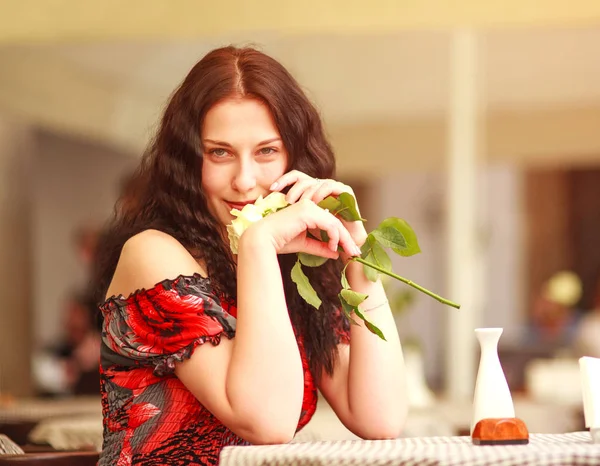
xmin=240 ymin=199 xmax=360 ymax=259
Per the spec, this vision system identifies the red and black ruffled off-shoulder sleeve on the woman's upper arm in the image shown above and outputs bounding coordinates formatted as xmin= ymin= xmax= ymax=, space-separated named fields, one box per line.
xmin=100 ymin=274 xmax=236 ymax=376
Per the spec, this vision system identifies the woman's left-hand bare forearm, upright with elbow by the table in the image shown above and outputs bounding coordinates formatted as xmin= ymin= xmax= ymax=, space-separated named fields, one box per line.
xmin=205 ymin=230 xmax=304 ymax=443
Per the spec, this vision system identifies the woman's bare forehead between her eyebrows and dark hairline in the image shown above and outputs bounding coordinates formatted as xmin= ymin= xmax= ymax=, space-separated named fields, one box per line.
xmin=202 ymin=99 xmax=279 ymax=142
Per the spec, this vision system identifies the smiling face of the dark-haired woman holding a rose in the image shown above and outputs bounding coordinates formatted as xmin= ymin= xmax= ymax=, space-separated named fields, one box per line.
xmin=201 ymin=99 xmax=288 ymax=229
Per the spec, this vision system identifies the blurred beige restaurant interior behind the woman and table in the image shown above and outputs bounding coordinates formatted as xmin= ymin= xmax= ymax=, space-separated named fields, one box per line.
xmin=0 ymin=0 xmax=600 ymax=452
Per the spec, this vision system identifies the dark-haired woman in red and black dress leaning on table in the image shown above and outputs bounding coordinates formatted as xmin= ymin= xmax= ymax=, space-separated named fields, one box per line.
xmin=96 ymin=47 xmax=406 ymax=465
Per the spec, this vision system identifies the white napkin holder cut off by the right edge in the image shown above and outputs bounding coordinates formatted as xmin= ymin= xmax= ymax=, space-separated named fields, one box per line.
xmin=579 ymin=356 xmax=600 ymax=444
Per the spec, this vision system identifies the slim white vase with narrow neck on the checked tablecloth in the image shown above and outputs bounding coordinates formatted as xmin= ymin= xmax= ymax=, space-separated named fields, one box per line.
xmin=471 ymin=328 xmax=515 ymax=434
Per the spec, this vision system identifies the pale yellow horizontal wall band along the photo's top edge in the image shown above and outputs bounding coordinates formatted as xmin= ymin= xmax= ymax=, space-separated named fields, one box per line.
xmin=0 ymin=0 xmax=600 ymax=42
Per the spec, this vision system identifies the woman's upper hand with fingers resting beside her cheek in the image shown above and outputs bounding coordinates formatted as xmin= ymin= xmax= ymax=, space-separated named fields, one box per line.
xmin=271 ymin=170 xmax=367 ymax=247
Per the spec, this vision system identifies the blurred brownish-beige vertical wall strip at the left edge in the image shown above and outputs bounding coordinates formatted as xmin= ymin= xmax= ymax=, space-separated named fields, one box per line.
xmin=0 ymin=115 xmax=33 ymax=395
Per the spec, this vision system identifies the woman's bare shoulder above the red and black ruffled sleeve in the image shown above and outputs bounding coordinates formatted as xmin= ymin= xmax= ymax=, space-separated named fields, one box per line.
xmin=107 ymin=230 xmax=206 ymax=297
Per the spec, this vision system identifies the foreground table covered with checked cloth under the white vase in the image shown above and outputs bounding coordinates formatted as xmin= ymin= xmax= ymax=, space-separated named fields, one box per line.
xmin=220 ymin=432 xmax=600 ymax=466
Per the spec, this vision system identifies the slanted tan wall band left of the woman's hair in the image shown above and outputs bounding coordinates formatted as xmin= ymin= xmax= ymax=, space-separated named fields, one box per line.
xmin=0 ymin=48 xmax=150 ymax=152
